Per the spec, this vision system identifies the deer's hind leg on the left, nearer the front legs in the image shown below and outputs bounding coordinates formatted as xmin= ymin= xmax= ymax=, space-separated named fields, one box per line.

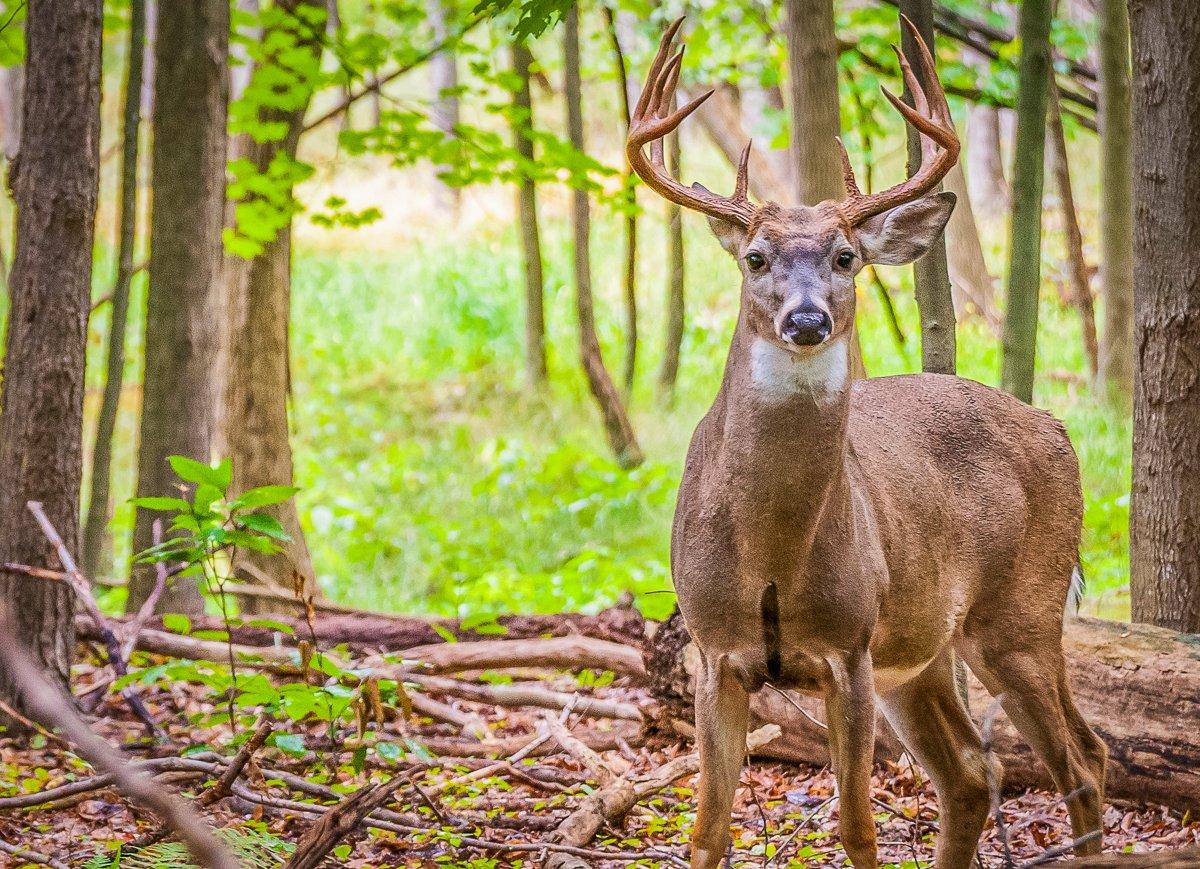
xmin=880 ymin=648 xmax=1001 ymax=869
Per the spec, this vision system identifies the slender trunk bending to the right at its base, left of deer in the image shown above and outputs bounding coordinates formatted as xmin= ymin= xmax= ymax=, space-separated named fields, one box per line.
xmin=563 ymin=6 xmax=642 ymax=468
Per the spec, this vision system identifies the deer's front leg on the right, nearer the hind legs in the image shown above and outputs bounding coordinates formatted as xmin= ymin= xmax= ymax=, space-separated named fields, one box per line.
xmin=826 ymin=651 xmax=877 ymax=869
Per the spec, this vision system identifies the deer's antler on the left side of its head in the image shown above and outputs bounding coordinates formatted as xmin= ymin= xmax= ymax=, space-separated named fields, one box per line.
xmin=625 ymin=18 xmax=757 ymax=227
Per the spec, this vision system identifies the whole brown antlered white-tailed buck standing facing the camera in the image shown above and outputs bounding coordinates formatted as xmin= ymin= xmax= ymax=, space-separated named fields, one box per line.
xmin=626 ymin=20 xmax=1106 ymax=869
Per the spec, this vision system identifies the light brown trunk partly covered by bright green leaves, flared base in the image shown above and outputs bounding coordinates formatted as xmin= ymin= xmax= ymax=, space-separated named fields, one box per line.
xmin=220 ymin=0 xmax=325 ymax=609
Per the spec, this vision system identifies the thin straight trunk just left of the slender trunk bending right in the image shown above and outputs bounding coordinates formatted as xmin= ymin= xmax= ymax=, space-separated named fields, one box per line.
xmin=512 ymin=42 xmax=547 ymax=389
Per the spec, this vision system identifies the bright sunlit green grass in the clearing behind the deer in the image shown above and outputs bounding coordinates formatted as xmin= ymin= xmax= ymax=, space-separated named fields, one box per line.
xmin=79 ymin=194 xmax=1130 ymax=616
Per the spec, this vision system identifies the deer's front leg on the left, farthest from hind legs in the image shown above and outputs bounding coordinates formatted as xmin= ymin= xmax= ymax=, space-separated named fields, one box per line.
xmin=691 ymin=654 xmax=750 ymax=869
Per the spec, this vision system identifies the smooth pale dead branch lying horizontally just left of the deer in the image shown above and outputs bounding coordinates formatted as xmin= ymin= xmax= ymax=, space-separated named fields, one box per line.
xmin=404 ymin=635 xmax=646 ymax=679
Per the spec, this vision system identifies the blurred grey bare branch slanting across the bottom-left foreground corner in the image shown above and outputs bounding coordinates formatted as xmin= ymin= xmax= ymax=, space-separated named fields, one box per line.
xmin=0 ymin=607 xmax=239 ymax=869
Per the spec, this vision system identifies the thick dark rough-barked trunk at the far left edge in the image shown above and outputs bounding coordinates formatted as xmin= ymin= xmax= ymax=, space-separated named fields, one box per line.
xmin=0 ymin=0 xmax=102 ymax=724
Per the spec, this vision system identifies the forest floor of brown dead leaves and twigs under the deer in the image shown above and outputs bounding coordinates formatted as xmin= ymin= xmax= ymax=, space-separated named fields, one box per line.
xmin=0 ymin=643 xmax=1200 ymax=869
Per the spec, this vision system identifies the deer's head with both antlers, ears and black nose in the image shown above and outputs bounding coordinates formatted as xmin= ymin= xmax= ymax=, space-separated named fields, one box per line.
xmin=625 ymin=18 xmax=959 ymax=354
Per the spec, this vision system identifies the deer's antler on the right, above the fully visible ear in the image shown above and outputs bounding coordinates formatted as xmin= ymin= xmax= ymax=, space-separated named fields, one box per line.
xmin=838 ymin=16 xmax=959 ymax=227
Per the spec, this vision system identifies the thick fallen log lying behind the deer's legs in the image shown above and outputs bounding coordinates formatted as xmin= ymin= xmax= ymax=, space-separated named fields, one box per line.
xmin=648 ymin=615 xmax=1200 ymax=811
